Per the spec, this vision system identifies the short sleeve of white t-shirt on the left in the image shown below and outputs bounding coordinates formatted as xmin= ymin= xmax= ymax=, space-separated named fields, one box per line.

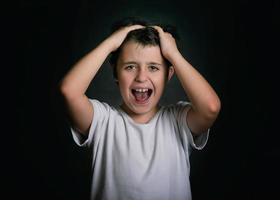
xmin=70 ymin=99 xmax=110 ymax=147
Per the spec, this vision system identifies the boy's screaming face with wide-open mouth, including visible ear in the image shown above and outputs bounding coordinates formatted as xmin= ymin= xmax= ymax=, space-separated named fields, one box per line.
xmin=117 ymin=41 xmax=173 ymax=118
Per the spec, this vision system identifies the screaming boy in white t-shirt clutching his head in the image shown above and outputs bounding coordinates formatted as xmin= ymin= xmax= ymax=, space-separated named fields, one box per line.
xmin=60 ymin=18 xmax=220 ymax=200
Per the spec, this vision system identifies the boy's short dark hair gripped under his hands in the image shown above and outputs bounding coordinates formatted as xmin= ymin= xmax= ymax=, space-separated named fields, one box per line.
xmin=109 ymin=17 xmax=179 ymax=78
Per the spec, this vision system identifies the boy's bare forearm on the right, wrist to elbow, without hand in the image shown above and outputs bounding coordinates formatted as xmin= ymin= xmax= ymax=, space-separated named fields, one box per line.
xmin=169 ymin=51 xmax=220 ymax=117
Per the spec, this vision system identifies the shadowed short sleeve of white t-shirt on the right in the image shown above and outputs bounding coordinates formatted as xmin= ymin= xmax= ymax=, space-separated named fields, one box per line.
xmin=176 ymin=101 xmax=210 ymax=150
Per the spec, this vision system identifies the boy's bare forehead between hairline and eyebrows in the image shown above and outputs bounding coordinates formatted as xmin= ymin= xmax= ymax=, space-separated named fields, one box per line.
xmin=119 ymin=41 xmax=164 ymax=64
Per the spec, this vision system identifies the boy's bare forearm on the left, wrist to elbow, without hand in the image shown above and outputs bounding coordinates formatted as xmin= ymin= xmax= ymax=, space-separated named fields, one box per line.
xmin=60 ymin=39 xmax=113 ymax=97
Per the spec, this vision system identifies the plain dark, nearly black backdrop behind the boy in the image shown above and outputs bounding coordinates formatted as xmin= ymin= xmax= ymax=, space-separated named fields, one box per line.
xmin=10 ymin=0 xmax=280 ymax=200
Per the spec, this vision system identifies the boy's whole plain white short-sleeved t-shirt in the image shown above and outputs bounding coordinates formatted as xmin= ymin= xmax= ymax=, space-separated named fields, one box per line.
xmin=71 ymin=99 xmax=209 ymax=200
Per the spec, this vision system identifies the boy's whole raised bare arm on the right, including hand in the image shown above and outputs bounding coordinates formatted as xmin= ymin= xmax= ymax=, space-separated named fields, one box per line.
xmin=155 ymin=26 xmax=221 ymax=135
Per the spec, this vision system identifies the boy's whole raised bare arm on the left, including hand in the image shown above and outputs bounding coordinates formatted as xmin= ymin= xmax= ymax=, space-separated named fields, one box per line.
xmin=60 ymin=25 xmax=142 ymax=136
